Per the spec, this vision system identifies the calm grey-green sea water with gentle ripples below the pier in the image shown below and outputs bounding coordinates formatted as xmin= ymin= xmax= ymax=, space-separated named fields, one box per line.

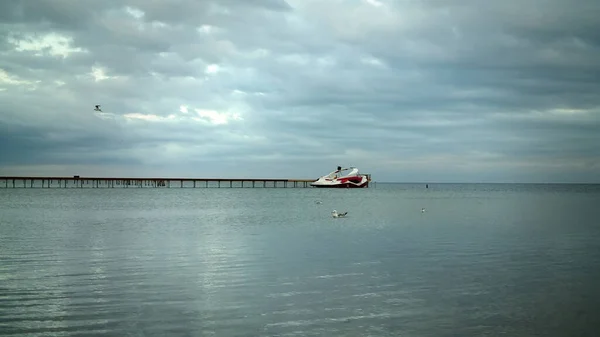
xmin=0 ymin=183 xmax=600 ymax=337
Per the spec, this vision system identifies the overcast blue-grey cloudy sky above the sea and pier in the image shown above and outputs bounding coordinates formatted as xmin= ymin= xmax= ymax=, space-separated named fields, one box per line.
xmin=0 ymin=0 xmax=600 ymax=183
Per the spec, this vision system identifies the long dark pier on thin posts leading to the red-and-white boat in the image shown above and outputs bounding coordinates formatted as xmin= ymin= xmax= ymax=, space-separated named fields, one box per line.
xmin=0 ymin=176 xmax=316 ymax=188
